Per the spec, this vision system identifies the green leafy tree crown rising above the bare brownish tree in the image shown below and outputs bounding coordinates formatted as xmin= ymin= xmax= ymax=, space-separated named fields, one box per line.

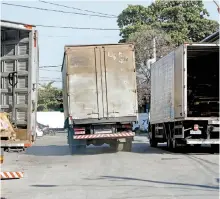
xmin=117 ymin=0 xmax=219 ymax=45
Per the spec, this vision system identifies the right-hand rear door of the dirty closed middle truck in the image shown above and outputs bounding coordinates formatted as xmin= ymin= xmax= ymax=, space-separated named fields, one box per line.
xmin=103 ymin=45 xmax=137 ymax=117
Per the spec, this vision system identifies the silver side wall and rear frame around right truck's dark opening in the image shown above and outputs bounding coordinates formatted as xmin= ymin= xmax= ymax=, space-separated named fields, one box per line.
xmin=150 ymin=44 xmax=219 ymax=124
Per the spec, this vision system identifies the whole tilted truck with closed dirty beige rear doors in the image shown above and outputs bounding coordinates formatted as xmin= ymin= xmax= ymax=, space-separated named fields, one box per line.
xmin=62 ymin=44 xmax=138 ymax=151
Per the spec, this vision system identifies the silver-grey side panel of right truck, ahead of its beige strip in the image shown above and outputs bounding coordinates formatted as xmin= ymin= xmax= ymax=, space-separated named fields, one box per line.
xmin=150 ymin=52 xmax=175 ymax=124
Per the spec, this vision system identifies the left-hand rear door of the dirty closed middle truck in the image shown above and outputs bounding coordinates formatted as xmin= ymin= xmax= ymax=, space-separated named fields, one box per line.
xmin=66 ymin=46 xmax=101 ymax=119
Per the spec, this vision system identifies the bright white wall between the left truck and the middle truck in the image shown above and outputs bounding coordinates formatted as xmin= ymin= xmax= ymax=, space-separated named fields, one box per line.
xmin=37 ymin=111 xmax=64 ymax=128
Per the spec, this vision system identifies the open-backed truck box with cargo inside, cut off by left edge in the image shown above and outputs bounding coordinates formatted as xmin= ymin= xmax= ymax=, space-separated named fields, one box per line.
xmin=0 ymin=20 xmax=39 ymax=149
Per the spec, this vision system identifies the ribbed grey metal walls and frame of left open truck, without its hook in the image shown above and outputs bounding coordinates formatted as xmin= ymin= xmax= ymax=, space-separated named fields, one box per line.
xmin=0 ymin=20 xmax=39 ymax=145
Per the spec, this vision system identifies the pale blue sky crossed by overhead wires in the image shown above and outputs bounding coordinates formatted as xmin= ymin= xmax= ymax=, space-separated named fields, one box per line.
xmin=1 ymin=0 xmax=219 ymax=88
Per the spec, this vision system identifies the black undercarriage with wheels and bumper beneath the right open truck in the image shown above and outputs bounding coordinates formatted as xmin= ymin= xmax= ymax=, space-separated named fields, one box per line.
xmin=149 ymin=120 xmax=220 ymax=151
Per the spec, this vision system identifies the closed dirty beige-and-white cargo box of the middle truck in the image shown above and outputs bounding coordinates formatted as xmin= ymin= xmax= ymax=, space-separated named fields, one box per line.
xmin=62 ymin=44 xmax=138 ymax=124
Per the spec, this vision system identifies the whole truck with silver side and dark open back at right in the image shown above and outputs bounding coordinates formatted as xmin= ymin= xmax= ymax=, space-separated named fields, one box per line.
xmin=149 ymin=43 xmax=219 ymax=150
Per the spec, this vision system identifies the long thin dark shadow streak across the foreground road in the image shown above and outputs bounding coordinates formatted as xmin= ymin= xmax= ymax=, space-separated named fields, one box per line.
xmin=90 ymin=176 xmax=219 ymax=190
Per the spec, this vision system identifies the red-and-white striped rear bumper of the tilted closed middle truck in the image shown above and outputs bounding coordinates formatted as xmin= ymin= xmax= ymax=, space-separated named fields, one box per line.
xmin=73 ymin=132 xmax=135 ymax=140
